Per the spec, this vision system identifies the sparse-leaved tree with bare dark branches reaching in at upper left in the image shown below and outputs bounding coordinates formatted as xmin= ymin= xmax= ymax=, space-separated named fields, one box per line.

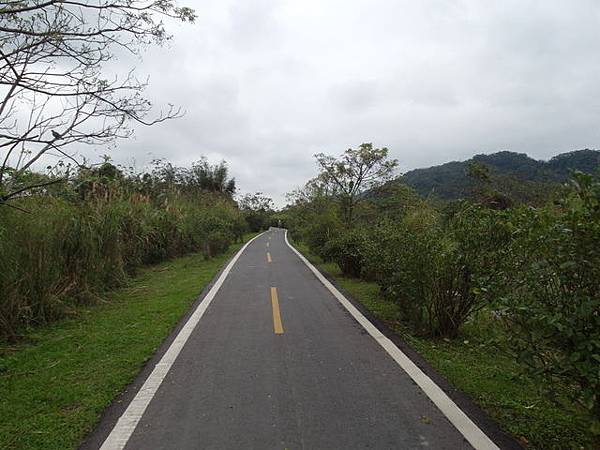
xmin=0 ymin=0 xmax=195 ymax=205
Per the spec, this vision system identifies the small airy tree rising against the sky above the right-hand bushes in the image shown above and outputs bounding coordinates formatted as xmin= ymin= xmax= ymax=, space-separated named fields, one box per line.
xmin=315 ymin=143 xmax=398 ymax=226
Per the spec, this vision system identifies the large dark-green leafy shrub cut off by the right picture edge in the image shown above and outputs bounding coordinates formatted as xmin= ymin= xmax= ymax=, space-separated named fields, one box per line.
xmin=491 ymin=173 xmax=600 ymax=428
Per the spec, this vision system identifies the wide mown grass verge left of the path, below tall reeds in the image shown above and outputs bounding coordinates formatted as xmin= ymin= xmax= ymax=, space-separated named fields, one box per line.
xmin=0 ymin=236 xmax=255 ymax=449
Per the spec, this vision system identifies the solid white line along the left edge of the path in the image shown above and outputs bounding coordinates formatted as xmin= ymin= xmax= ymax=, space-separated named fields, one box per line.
xmin=100 ymin=233 xmax=264 ymax=450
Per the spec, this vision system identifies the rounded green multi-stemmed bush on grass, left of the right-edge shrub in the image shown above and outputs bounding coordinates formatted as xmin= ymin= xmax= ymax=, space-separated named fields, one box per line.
xmin=361 ymin=205 xmax=502 ymax=337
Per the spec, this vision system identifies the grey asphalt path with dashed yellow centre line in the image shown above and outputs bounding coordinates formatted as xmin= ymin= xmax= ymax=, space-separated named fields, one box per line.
xmin=91 ymin=229 xmax=495 ymax=450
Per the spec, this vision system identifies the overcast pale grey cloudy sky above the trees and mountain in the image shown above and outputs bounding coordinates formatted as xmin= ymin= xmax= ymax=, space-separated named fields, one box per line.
xmin=94 ymin=0 xmax=600 ymax=205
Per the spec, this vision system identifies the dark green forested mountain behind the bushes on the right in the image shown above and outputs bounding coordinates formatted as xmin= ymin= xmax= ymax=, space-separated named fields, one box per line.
xmin=399 ymin=149 xmax=600 ymax=200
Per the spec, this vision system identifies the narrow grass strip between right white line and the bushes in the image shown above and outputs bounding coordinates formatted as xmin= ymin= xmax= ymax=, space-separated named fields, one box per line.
xmin=294 ymin=243 xmax=597 ymax=450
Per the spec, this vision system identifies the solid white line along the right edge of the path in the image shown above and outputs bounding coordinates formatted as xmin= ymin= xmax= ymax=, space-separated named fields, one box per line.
xmin=285 ymin=230 xmax=499 ymax=450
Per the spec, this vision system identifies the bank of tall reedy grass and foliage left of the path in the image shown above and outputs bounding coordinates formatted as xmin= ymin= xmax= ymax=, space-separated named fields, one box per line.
xmin=0 ymin=161 xmax=246 ymax=338
